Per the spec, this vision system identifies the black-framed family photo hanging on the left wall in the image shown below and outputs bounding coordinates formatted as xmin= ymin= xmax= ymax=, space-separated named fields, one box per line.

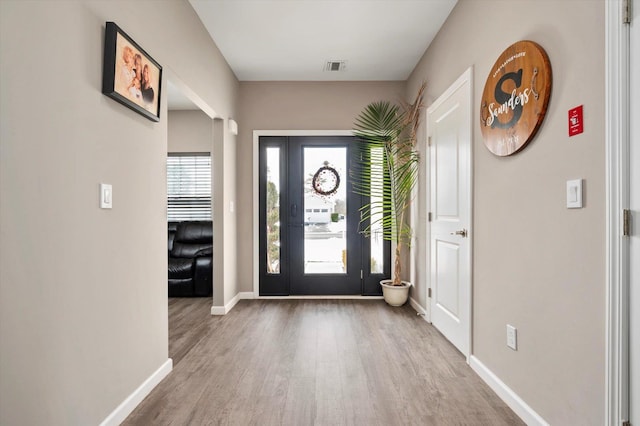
xmin=102 ymin=22 xmax=162 ymax=122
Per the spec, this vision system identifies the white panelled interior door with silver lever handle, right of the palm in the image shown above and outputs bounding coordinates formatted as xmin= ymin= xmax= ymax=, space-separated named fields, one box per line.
xmin=427 ymin=68 xmax=472 ymax=357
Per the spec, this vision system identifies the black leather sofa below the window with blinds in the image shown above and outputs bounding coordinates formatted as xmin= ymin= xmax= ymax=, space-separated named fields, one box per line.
xmin=168 ymin=220 xmax=213 ymax=297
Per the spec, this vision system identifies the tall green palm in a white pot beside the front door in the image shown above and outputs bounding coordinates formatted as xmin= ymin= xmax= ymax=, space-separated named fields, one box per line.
xmin=352 ymin=83 xmax=425 ymax=306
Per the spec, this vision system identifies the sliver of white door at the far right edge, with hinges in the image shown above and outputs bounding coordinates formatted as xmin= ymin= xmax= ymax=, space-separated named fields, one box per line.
xmin=629 ymin=3 xmax=640 ymax=425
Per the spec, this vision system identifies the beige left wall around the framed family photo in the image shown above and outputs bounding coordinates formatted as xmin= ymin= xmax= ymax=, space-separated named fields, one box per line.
xmin=0 ymin=0 xmax=238 ymax=425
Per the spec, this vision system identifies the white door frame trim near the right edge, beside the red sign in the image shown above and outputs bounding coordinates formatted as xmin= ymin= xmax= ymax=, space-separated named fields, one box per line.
xmin=605 ymin=0 xmax=630 ymax=426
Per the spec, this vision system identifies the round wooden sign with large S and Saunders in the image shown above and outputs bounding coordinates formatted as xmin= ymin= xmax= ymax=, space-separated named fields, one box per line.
xmin=480 ymin=40 xmax=551 ymax=156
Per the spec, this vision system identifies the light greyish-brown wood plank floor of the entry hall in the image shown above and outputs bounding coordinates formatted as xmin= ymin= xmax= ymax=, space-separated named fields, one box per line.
xmin=123 ymin=299 xmax=524 ymax=426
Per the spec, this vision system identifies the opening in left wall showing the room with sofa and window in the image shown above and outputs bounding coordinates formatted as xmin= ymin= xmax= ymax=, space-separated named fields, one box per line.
xmin=164 ymin=75 xmax=219 ymax=367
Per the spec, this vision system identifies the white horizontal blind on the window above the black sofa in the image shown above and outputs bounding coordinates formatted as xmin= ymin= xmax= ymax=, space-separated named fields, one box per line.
xmin=167 ymin=153 xmax=211 ymax=222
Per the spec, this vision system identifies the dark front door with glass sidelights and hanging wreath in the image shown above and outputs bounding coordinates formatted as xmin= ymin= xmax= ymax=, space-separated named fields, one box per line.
xmin=259 ymin=136 xmax=390 ymax=295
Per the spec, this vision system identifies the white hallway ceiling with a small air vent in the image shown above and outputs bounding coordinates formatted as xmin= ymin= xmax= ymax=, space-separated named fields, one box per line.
xmin=169 ymin=0 xmax=457 ymax=108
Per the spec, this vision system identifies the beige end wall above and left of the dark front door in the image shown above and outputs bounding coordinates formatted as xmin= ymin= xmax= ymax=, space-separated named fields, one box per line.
xmin=237 ymin=82 xmax=405 ymax=291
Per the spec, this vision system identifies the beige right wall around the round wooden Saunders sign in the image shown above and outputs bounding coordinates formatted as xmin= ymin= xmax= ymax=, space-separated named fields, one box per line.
xmin=408 ymin=0 xmax=605 ymax=425
